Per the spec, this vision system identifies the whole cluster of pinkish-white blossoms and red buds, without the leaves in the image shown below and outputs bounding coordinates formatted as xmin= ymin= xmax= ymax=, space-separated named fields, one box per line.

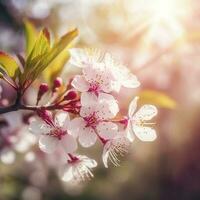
xmin=30 ymin=49 xmax=157 ymax=181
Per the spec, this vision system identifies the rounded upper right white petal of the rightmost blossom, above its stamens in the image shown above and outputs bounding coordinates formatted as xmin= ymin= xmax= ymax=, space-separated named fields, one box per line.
xmin=135 ymin=104 xmax=158 ymax=120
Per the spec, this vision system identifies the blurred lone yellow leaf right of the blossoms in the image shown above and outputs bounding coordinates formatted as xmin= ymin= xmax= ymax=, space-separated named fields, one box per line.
xmin=137 ymin=90 xmax=176 ymax=109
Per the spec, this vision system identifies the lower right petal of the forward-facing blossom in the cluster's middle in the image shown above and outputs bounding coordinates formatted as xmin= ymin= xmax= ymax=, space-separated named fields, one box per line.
xmin=96 ymin=122 xmax=118 ymax=139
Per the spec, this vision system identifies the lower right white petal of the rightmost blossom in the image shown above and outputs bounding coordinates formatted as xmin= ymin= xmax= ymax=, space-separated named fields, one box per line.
xmin=133 ymin=126 xmax=157 ymax=142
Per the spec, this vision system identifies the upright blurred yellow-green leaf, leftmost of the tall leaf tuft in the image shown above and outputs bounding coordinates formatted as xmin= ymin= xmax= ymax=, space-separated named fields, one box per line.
xmin=24 ymin=21 xmax=37 ymax=56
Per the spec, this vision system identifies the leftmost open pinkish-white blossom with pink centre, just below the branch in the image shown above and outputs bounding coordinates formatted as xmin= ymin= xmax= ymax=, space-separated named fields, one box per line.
xmin=29 ymin=111 xmax=77 ymax=153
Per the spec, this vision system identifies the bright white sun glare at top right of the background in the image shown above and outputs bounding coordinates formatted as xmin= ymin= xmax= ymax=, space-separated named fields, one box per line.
xmin=127 ymin=0 xmax=190 ymax=48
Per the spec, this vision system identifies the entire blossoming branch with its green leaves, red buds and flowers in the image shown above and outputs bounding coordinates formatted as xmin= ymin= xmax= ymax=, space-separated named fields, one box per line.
xmin=0 ymin=22 xmax=157 ymax=181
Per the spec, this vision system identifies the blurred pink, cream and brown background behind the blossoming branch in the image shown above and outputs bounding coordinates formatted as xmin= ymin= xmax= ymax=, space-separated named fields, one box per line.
xmin=0 ymin=0 xmax=200 ymax=200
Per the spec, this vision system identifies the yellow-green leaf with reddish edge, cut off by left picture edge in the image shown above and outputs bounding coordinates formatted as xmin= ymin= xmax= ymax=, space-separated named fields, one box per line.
xmin=0 ymin=51 xmax=19 ymax=79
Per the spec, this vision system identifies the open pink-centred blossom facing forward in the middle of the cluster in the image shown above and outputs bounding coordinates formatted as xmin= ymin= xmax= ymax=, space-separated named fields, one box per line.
xmin=71 ymin=93 xmax=119 ymax=147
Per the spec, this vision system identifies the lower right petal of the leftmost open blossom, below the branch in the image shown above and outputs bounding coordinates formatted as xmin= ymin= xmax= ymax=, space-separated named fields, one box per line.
xmin=60 ymin=134 xmax=77 ymax=153
